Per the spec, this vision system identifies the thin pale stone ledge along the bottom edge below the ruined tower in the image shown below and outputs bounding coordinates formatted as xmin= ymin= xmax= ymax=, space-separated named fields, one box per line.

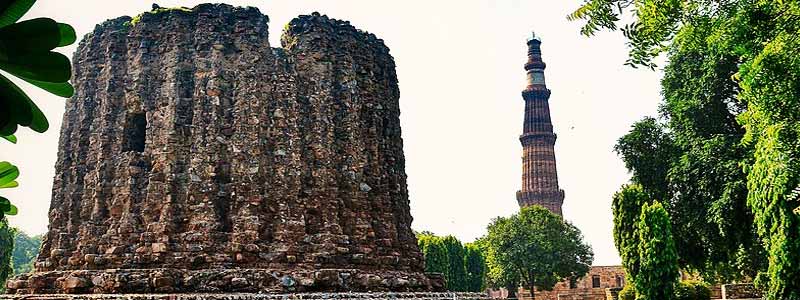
xmin=0 ymin=292 xmax=490 ymax=300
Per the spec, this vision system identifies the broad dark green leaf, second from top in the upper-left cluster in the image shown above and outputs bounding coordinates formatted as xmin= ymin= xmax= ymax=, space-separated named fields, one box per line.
xmin=0 ymin=18 xmax=60 ymax=54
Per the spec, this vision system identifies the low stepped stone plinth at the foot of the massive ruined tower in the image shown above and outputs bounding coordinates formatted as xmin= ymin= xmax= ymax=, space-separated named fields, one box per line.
xmin=0 ymin=268 xmax=444 ymax=299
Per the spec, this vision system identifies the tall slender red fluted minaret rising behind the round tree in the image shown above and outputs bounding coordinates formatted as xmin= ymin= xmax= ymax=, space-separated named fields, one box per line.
xmin=517 ymin=34 xmax=564 ymax=215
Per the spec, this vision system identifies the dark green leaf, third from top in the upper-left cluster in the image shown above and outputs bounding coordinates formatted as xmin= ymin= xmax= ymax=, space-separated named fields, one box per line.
xmin=0 ymin=52 xmax=72 ymax=83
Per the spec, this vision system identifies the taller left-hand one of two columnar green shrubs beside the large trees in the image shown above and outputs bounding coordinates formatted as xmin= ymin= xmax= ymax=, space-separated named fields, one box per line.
xmin=611 ymin=184 xmax=650 ymax=288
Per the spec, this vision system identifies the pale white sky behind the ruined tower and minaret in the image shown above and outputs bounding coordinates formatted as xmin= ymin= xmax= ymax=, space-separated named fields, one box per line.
xmin=0 ymin=0 xmax=661 ymax=265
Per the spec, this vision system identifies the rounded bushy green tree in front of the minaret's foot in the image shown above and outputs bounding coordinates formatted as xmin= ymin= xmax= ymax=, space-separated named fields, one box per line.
xmin=485 ymin=205 xmax=594 ymax=298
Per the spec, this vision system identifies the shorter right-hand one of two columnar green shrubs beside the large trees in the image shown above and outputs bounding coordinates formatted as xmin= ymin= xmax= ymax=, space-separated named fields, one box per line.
xmin=634 ymin=201 xmax=680 ymax=300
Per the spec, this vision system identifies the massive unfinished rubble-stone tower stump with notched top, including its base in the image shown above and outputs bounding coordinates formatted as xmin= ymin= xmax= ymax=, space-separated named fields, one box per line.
xmin=8 ymin=4 xmax=441 ymax=293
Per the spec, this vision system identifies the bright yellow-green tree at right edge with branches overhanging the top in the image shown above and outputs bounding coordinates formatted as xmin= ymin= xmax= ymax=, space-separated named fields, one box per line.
xmin=570 ymin=0 xmax=800 ymax=300
